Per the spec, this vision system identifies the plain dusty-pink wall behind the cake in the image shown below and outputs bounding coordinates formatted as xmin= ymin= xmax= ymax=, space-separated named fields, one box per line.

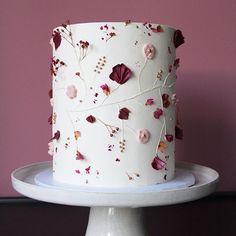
xmin=0 ymin=0 xmax=236 ymax=196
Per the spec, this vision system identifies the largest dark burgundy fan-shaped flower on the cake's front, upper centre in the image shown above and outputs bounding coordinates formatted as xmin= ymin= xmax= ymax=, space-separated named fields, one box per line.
xmin=109 ymin=63 xmax=132 ymax=84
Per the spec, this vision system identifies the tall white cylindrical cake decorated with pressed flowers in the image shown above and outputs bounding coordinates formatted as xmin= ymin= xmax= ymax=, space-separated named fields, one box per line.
xmin=48 ymin=21 xmax=184 ymax=188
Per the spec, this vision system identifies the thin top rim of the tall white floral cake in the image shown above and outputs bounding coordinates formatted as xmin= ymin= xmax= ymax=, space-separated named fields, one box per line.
xmin=53 ymin=20 xmax=178 ymax=31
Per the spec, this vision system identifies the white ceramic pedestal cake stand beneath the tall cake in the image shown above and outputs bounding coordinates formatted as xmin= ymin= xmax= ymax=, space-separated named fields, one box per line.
xmin=11 ymin=162 xmax=219 ymax=236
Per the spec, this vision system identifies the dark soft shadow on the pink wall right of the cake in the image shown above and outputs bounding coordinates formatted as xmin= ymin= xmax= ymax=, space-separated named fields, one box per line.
xmin=176 ymin=73 xmax=236 ymax=191
